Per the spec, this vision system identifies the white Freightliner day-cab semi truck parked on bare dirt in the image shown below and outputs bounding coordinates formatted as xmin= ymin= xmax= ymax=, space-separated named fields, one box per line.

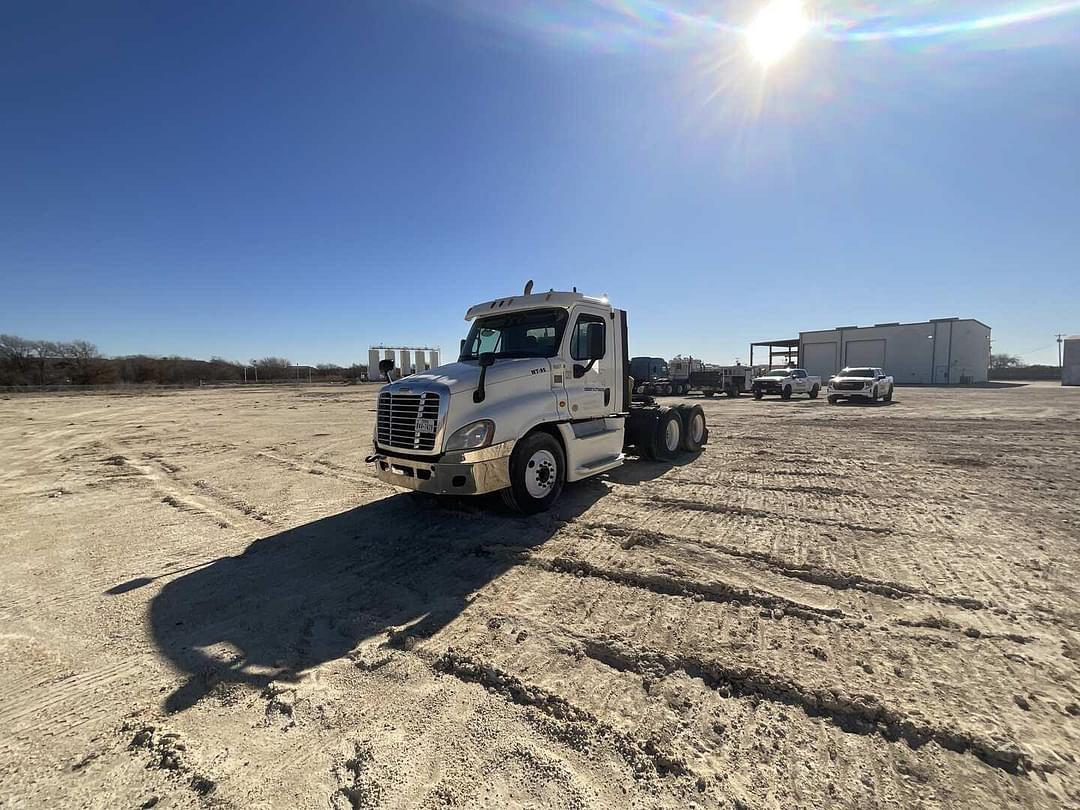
xmin=367 ymin=282 xmax=708 ymax=513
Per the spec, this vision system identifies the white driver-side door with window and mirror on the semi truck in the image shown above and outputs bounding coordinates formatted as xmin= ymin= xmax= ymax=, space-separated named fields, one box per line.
xmin=564 ymin=309 xmax=618 ymax=419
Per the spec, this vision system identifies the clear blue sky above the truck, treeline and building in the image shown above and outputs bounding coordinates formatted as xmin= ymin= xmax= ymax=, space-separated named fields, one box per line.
xmin=0 ymin=0 xmax=1080 ymax=363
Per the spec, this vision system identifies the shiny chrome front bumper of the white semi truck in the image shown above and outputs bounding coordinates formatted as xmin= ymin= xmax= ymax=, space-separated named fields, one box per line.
xmin=368 ymin=441 xmax=514 ymax=495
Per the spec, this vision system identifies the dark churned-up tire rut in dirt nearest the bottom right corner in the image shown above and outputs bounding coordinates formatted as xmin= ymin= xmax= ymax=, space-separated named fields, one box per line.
xmin=579 ymin=638 xmax=1038 ymax=774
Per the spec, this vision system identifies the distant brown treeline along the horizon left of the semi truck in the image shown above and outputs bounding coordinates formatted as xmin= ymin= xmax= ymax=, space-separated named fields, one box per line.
xmin=0 ymin=335 xmax=367 ymax=386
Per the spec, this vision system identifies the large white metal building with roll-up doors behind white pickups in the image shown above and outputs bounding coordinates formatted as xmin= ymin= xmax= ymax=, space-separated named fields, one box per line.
xmin=799 ymin=318 xmax=990 ymax=384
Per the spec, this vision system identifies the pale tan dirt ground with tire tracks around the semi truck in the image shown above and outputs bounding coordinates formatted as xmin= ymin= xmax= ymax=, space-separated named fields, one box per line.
xmin=0 ymin=384 xmax=1080 ymax=808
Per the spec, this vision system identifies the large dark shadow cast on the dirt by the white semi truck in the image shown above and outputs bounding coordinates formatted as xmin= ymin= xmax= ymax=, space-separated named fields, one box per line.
xmin=130 ymin=462 xmax=686 ymax=712
